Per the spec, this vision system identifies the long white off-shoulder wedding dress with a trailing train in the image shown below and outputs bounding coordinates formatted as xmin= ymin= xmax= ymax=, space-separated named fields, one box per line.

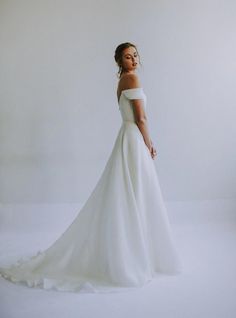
xmin=0 ymin=88 xmax=182 ymax=292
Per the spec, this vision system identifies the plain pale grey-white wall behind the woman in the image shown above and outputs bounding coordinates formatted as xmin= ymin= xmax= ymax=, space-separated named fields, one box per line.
xmin=0 ymin=0 xmax=236 ymax=203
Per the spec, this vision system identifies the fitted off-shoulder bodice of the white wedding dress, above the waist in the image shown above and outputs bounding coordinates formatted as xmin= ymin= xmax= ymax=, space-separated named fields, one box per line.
xmin=119 ymin=87 xmax=147 ymax=122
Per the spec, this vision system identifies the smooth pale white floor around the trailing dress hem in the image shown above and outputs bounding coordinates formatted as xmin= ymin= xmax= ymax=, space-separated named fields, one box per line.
xmin=0 ymin=202 xmax=236 ymax=318
